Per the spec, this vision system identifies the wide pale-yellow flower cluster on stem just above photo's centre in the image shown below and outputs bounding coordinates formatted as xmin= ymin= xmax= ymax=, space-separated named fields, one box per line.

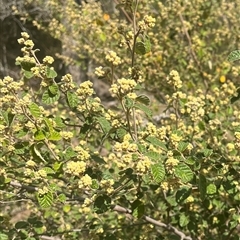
xmin=109 ymin=78 xmax=137 ymax=97
